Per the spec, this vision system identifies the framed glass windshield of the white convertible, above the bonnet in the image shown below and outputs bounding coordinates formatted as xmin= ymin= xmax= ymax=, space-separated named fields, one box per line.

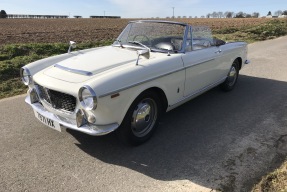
xmin=113 ymin=22 xmax=188 ymax=52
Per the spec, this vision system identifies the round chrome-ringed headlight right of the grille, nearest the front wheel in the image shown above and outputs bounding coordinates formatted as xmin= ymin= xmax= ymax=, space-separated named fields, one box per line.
xmin=78 ymin=85 xmax=98 ymax=111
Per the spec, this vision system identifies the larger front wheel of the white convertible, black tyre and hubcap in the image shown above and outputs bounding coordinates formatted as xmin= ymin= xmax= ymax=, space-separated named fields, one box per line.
xmin=116 ymin=91 xmax=162 ymax=146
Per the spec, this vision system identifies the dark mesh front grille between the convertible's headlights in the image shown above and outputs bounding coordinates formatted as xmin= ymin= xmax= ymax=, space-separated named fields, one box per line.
xmin=35 ymin=84 xmax=76 ymax=112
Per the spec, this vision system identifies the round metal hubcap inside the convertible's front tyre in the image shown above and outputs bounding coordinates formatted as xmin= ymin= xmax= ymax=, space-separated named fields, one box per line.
xmin=131 ymin=98 xmax=157 ymax=137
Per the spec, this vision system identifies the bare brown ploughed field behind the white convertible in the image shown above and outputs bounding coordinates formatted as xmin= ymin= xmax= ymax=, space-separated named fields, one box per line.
xmin=0 ymin=18 xmax=270 ymax=45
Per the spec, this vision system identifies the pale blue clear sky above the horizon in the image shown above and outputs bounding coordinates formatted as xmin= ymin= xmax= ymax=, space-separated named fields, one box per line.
xmin=0 ymin=0 xmax=287 ymax=18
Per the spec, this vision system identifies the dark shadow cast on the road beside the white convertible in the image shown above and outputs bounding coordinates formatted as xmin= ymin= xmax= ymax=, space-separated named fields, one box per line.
xmin=68 ymin=75 xmax=287 ymax=191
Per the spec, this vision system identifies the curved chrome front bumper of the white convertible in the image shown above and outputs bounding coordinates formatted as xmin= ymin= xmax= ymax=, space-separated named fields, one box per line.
xmin=25 ymin=95 xmax=119 ymax=136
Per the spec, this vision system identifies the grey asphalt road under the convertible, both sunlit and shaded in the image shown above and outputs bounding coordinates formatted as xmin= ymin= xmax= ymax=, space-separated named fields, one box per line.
xmin=0 ymin=37 xmax=287 ymax=192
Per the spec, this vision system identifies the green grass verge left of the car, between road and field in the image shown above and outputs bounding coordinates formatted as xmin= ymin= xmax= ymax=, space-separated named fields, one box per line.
xmin=0 ymin=41 xmax=112 ymax=99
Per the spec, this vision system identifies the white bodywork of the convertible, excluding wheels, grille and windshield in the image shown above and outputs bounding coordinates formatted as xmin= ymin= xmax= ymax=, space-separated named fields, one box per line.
xmin=21 ymin=20 xmax=250 ymax=135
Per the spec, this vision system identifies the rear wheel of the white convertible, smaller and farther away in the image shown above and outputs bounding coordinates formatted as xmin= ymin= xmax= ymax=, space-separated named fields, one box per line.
xmin=220 ymin=60 xmax=239 ymax=92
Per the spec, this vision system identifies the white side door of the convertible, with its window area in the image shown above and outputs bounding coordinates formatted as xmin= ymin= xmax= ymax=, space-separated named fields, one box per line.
xmin=182 ymin=26 xmax=225 ymax=97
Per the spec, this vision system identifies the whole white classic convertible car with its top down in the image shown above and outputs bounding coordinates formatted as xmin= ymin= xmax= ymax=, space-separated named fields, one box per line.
xmin=20 ymin=20 xmax=249 ymax=145
